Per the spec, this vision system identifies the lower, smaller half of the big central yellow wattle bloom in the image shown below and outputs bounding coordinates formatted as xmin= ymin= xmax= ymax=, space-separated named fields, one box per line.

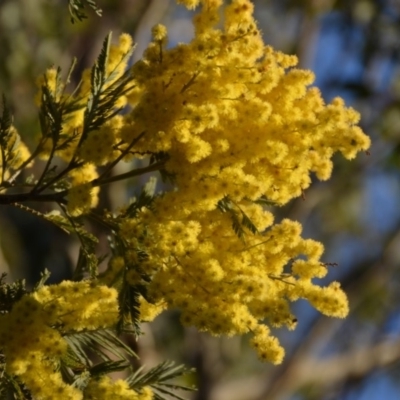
xmin=120 ymin=205 xmax=348 ymax=363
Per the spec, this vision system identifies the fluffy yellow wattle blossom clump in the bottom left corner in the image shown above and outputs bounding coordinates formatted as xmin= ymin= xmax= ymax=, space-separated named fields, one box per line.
xmin=0 ymin=281 xmax=118 ymax=400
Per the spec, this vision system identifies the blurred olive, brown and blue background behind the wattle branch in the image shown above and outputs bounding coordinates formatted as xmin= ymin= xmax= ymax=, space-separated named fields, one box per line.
xmin=0 ymin=0 xmax=400 ymax=400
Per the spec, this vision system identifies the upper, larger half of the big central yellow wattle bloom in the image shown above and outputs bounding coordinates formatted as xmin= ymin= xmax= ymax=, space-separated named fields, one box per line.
xmin=121 ymin=0 xmax=369 ymax=209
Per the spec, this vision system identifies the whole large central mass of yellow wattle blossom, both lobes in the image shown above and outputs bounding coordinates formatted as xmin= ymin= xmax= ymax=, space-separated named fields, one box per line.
xmin=120 ymin=0 xmax=370 ymax=363
